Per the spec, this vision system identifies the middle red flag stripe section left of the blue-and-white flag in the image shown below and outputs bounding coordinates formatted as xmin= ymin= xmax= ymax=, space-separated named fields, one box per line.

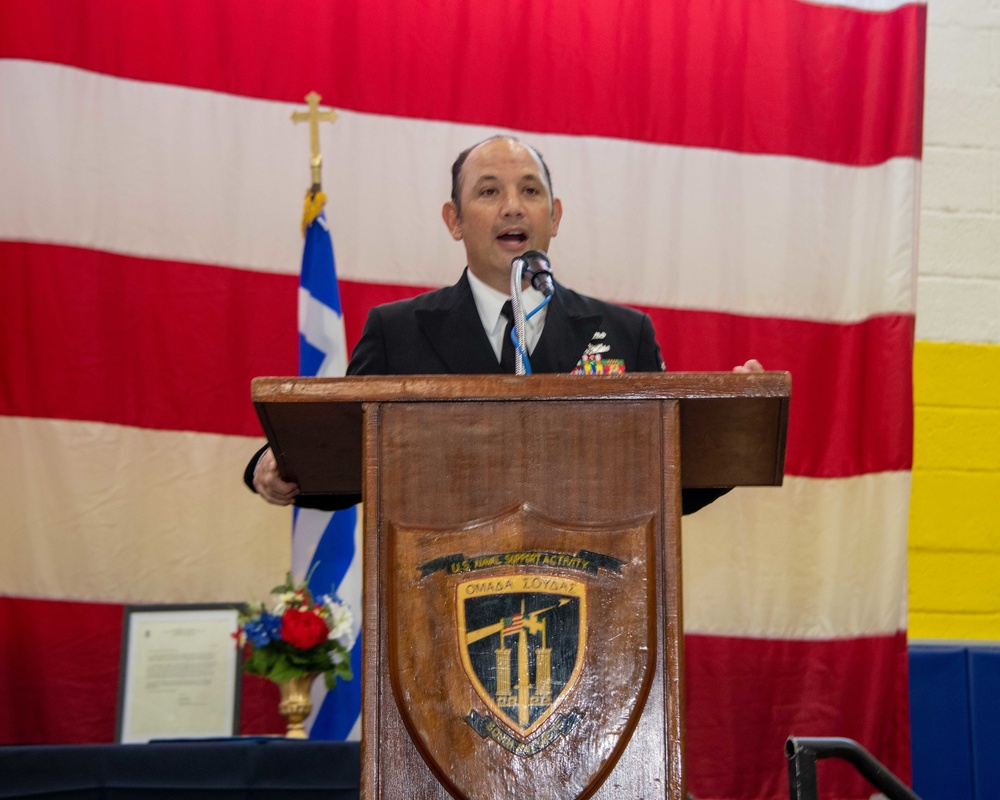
xmin=0 ymin=242 xmax=298 ymax=436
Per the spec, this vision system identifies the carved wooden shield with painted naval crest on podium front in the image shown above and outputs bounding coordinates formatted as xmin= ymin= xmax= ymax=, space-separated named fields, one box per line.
xmin=388 ymin=508 xmax=656 ymax=800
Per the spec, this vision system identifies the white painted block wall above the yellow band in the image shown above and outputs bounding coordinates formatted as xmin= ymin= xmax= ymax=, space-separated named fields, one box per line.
xmin=917 ymin=0 xmax=1000 ymax=343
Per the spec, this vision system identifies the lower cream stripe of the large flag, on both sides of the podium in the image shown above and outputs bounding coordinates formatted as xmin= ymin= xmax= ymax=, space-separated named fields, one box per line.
xmin=0 ymin=410 xmax=910 ymax=639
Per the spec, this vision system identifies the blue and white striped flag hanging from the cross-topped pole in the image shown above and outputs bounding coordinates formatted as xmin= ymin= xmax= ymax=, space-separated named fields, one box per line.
xmin=292 ymin=194 xmax=361 ymax=741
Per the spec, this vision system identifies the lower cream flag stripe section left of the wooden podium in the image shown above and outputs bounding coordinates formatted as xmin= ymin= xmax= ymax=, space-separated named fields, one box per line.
xmin=0 ymin=416 xmax=291 ymax=603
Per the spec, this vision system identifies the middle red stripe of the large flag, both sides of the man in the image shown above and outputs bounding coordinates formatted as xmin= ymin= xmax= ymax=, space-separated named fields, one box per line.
xmin=0 ymin=242 xmax=913 ymax=477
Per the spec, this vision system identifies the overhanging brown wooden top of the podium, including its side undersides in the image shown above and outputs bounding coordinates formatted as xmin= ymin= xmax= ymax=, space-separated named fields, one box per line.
xmin=252 ymin=372 xmax=791 ymax=495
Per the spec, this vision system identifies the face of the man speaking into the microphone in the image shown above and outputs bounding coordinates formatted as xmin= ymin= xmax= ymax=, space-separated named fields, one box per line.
xmin=442 ymin=139 xmax=562 ymax=292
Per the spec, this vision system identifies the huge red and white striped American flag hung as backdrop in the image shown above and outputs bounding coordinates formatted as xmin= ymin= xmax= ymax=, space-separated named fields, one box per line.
xmin=0 ymin=0 xmax=926 ymax=800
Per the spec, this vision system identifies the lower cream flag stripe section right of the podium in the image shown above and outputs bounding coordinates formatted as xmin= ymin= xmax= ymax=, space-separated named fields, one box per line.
xmin=683 ymin=472 xmax=910 ymax=639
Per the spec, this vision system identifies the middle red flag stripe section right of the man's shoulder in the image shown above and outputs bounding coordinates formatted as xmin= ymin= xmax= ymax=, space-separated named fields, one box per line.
xmin=645 ymin=308 xmax=914 ymax=478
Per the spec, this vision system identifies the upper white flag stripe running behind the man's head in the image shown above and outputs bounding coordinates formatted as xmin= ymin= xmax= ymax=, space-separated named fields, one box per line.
xmin=0 ymin=60 xmax=917 ymax=322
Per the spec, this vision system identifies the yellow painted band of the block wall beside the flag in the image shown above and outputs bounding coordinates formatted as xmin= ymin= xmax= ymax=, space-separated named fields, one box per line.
xmin=908 ymin=342 xmax=1000 ymax=640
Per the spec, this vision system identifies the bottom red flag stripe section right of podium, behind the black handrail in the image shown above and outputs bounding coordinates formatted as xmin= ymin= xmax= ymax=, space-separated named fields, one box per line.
xmin=684 ymin=633 xmax=910 ymax=798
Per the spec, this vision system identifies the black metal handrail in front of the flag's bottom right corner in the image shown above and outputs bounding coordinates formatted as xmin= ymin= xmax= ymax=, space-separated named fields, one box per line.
xmin=785 ymin=736 xmax=920 ymax=800
